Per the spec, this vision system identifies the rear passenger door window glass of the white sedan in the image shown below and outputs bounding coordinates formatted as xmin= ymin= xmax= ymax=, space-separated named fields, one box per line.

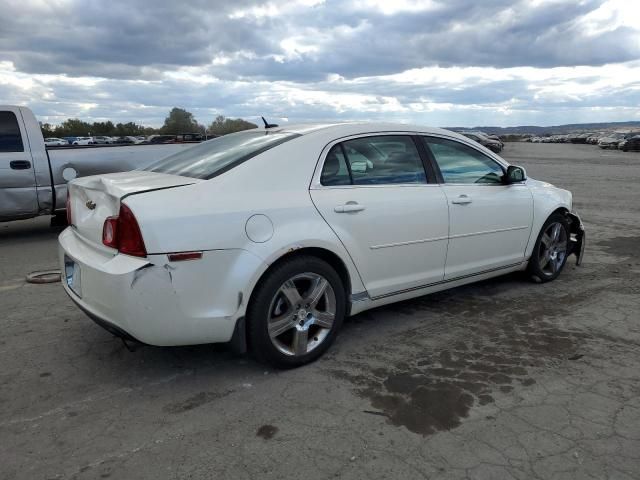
xmin=320 ymin=135 xmax=427 ymax=186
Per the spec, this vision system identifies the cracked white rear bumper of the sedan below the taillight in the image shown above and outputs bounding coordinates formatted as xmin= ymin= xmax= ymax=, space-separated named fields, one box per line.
xmin=59 ymin=227 xmax=261 ymax=346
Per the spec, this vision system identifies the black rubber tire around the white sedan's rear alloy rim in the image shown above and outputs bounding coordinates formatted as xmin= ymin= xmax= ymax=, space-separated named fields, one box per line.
xmin=247 ymin=255 xmax=346 ymax=368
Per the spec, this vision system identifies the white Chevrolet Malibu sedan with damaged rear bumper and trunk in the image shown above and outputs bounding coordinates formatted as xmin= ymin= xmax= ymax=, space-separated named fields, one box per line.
xmin=59 ymin=123 xmax=584 ymax=367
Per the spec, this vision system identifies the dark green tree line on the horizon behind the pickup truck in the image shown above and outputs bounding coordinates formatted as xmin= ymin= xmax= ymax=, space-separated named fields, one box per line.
xmin=40 ymin=107 xmax=257 ymax=138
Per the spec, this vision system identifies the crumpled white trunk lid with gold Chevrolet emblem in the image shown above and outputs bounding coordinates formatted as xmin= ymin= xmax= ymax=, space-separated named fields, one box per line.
xmin=68 ymin=171 xmax=203 ymax=248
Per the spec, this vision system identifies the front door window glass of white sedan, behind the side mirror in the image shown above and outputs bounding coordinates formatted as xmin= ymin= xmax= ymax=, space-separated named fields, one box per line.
xmin=422 ymin=137 xmax=504 ymax=185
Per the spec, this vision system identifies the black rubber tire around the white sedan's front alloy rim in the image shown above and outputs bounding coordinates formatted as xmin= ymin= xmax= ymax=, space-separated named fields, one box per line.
xmin=527 ymin=213 xmax=571 ymax=283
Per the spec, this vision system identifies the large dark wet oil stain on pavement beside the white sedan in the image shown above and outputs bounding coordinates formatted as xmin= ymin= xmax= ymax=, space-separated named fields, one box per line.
xmin=331 ymin=274 xmax=590 ymax=435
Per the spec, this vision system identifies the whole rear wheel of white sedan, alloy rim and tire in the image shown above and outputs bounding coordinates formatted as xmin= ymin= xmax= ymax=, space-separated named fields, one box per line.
xmin=247 ymin=256 xmax=346 ymax=368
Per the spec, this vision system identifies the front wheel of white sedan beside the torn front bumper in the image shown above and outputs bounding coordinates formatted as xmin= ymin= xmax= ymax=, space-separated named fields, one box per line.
xmin=527 ymin=213 xmax=570 ymax=283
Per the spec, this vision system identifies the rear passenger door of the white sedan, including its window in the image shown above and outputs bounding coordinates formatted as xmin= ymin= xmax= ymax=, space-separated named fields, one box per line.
xmin=310 ymin=134 xmax=448 ymax=298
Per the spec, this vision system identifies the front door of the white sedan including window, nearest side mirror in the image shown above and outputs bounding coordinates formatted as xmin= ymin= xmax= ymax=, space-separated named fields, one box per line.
xmin=422 ymin=137 xmax=533 ymax=280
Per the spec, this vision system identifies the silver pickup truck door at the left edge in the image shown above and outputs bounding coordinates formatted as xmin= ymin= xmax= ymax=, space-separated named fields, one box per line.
xmin=0 ymin=107 xmax=38 ymax=218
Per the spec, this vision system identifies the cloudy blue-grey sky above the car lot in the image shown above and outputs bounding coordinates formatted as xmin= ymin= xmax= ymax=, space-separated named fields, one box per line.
xmin=0 ymin=0 xmax=640 ymax=127
